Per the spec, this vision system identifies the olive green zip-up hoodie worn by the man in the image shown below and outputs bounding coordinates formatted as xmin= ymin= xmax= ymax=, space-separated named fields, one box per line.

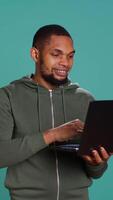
xmin=0 ymin=77 xmax=107 ymax=200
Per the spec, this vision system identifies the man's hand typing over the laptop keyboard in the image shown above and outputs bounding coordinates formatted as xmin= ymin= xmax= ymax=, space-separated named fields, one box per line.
xmin=44 ymin=119 xmax=84 ymax=144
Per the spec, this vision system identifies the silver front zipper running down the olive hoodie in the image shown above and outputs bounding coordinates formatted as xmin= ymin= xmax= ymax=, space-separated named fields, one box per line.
xmin=49 ymin=90 xmax=60 ymax=200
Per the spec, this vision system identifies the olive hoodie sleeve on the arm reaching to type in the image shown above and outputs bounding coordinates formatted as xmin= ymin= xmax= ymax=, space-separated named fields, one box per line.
xmin=0 ymin=89 xmax=47 ymax=167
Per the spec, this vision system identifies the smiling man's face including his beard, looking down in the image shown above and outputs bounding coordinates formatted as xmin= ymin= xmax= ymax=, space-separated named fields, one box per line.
xmin=37 ymin=35 xmax=75 ymax=85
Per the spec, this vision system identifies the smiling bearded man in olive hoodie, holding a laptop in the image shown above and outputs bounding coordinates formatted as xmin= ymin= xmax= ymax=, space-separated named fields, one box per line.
xmin=0 ymin=25 xmax=109 ymax=200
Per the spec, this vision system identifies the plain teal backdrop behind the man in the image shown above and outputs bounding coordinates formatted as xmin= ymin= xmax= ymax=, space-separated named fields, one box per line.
xmin=0 ymin=0 xmax=113 ymax=200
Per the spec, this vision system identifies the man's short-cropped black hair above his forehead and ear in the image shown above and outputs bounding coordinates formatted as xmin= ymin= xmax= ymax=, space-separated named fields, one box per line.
xmin=32 ymin=24 xmax=72 ymax=48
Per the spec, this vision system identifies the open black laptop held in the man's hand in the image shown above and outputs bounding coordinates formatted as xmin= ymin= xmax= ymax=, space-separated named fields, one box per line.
xmin=56 ymin=100 xmax=113 ymax=155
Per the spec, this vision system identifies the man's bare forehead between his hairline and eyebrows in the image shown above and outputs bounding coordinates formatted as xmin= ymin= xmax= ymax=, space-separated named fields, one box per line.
xmin=45 ymin=35 xmax=74 ymax=53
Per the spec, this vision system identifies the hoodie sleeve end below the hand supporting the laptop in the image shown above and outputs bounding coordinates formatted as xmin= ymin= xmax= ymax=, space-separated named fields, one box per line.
xmin=86 ymin=162 xmax=108 ymax=179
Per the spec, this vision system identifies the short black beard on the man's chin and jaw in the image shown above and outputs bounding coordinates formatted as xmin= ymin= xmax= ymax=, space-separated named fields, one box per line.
xmin=42 ymin=73 xmax=68 ymax=86
